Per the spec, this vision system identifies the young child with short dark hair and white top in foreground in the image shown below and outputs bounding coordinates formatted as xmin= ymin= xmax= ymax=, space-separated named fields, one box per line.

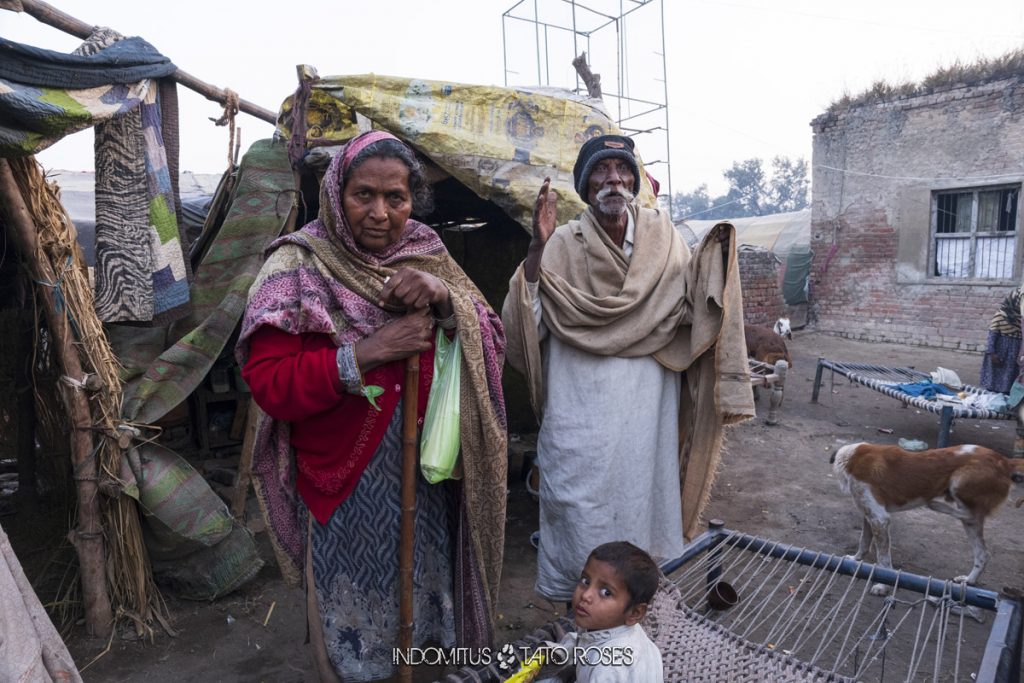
xmin=544 ymin=541 xmax=664 ymax=683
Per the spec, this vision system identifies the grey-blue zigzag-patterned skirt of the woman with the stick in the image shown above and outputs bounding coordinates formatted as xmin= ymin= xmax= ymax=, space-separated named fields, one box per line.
xmin=311 ymin=405 xmax=455 ymax=681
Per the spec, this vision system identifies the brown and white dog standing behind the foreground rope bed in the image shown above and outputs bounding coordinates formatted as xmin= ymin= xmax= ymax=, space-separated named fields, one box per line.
xmin=829 ymin=443 xmax=1024 ymax=595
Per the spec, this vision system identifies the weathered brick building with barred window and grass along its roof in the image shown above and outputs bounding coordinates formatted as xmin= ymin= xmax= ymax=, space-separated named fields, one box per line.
xmin=811 ymin=72 xmax=1024 ymax=350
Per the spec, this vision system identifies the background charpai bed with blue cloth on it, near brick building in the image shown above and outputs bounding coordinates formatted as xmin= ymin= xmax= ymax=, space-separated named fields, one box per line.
xmin=811 ymin=358 xmax=1024 ymax=455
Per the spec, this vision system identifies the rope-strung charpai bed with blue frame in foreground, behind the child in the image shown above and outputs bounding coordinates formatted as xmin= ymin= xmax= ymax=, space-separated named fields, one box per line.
xmin=442 ymin=521 xmax=1024 ymax=683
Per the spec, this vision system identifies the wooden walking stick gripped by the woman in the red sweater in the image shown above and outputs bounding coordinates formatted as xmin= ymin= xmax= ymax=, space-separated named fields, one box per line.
xmin=398 ymin=353 xmax=420 ymax=683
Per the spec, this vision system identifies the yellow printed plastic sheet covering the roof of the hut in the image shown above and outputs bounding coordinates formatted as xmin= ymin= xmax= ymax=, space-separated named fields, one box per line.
xmin=278 ymin=67 xmax=655 ymax=231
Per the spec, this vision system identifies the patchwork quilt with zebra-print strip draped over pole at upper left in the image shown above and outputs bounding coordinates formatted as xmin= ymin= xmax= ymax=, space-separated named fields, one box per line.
xmin=0 ymin=29 xmax=191 ymax=325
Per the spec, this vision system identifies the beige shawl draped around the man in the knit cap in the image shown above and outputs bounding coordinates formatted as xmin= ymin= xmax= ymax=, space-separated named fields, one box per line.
xmin=502 ymin=208 xmax=754 ymax=539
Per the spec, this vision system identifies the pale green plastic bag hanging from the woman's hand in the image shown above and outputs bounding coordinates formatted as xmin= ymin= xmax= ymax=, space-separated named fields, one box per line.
xmin=420 ymin=328 xmax=462 ymax=483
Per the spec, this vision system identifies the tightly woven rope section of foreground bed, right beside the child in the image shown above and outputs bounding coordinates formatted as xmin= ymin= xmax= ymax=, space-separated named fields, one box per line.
xmin=643 ymin=582 xmax=850 ymax=683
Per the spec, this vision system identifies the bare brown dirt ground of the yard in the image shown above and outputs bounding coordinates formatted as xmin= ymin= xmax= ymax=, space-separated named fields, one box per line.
xmin=12 ymin=332 xmax=1024 ymax=683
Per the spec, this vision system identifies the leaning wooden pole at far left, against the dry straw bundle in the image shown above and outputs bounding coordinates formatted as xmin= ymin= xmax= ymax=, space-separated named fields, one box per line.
xmin=0 ymin=159 xmax=114 ymax=638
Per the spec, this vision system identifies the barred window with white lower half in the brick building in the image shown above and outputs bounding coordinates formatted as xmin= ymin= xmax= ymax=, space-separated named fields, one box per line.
xmin=932 ymin=185 xmax=1020 ymax=280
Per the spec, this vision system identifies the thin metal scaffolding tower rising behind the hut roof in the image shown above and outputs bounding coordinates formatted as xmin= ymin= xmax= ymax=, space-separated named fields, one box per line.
xmin=502 ymin=0 xmax=672 ymax=205
